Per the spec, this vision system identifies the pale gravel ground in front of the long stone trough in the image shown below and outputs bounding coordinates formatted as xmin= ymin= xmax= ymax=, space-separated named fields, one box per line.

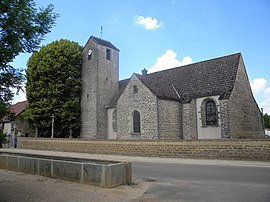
xmin=0 ymin=169 xmax=150 ymax=202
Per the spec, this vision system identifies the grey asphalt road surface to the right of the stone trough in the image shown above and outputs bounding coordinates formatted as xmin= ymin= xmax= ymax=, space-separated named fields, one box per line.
xmin=132 ymin=162 xmax=270 ymax=202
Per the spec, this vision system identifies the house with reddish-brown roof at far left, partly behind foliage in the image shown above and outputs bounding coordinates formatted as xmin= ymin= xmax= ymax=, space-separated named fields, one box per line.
xmin=2 ymin=101 xmax=33 ymax=147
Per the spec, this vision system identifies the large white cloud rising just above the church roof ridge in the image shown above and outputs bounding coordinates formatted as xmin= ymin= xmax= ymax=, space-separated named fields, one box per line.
xmin=148 ymin=49 xmax=192 ymax=73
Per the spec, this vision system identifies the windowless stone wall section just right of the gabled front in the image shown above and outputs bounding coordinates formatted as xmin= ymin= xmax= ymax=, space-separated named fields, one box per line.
xmin=158 ymin=100 xmax=182 ymax=140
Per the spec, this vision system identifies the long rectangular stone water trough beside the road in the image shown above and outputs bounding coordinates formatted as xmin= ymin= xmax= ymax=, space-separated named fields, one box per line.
xmin=0 ymin=153 xmax=132 ymax=188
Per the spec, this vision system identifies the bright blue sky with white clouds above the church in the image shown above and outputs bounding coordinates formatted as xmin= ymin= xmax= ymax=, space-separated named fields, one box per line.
xmin=13 ymin=0 xmax=270 ymax=114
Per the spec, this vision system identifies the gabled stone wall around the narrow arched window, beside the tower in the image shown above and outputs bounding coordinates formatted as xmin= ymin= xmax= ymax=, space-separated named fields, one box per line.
xmin=117 ymin=75 xmax=158 ymax=139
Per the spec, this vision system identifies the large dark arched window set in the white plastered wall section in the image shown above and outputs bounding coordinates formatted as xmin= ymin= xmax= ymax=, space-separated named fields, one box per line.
xmin=205 ymin=100 xmax=218 ymax=126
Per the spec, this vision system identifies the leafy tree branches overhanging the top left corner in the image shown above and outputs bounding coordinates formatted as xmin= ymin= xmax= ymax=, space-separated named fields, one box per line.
xmin=0 ymin=0 xmax=58 ymax=114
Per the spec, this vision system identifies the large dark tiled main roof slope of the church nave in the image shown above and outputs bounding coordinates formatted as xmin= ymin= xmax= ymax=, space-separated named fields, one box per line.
xmin=136 ymin=53 xmax=241 ymax=103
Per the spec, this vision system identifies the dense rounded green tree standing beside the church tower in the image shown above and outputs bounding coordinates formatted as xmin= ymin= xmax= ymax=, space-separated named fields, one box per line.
xmin=26 ymin=39 xmax=82 ymax=137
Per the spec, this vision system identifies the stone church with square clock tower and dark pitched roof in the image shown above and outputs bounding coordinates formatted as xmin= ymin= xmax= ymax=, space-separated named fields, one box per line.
xmin=81 ymin=36 xmax=264 ymax=140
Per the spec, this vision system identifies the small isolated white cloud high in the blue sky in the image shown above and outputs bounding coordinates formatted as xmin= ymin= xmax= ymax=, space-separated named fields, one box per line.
xmin=134 ymin=15 xmax=163 ymax=30
